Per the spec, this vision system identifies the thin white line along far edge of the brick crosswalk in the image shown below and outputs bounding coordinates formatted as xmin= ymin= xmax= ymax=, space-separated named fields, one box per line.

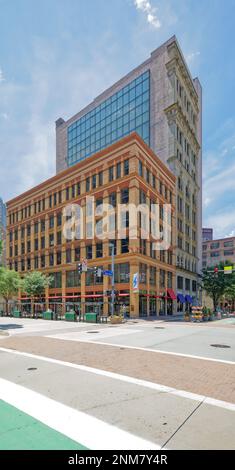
xmin=47 ymin=334 xmax=235 ymax=365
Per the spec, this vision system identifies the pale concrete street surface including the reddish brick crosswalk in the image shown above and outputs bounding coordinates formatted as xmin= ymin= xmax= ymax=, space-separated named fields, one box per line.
xmin=0 ymin=318 xmax=235 ymax=449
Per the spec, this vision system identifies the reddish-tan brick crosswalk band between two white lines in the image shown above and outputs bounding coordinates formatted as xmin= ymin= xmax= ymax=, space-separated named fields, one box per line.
xmin=1 ymin=336 xmax=235 ymax=403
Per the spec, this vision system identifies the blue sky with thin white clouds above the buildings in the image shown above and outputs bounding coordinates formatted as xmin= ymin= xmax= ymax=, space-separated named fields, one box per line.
xmin=0 ymin=0 xmax=235 ymax=237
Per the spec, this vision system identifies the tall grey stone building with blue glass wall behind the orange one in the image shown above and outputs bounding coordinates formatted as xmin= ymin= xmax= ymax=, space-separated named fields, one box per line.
xmin=56 ymin=37 xmax=202 ymax=309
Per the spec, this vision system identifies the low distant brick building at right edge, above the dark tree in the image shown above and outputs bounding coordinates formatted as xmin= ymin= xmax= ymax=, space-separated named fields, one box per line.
xmin=202 ymin=237 xmax=235 ymax=269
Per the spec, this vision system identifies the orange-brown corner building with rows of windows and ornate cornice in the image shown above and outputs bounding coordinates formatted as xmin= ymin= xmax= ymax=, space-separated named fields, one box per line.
xmin=7 ymin=133 xmax=176 ymax=316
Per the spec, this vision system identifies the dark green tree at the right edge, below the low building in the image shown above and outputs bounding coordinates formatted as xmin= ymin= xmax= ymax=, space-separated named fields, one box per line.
xmin=202 ymin=262 xmax=235 ymax=311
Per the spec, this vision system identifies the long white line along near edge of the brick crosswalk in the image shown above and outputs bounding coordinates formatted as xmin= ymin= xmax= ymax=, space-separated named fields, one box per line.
xmin=0 ymin=348 xmax=235 ymax=411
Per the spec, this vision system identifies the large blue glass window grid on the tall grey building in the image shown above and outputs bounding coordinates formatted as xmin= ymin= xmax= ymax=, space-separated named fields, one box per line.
xmin=67 ymin=71 xmax=150 ymax=166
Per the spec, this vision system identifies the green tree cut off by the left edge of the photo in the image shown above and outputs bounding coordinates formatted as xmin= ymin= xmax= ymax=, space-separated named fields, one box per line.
xmin=0 ymin=267 xmax=21 ymax=312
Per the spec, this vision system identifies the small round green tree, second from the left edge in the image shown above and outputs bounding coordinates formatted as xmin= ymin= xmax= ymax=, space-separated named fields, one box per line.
xmin=22 ymin=271 xmax=53 ymax=299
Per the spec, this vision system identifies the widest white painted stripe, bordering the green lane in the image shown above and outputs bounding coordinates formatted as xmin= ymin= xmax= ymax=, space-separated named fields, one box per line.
xmin=0 ymin=379 xmax=161 ymax=450
